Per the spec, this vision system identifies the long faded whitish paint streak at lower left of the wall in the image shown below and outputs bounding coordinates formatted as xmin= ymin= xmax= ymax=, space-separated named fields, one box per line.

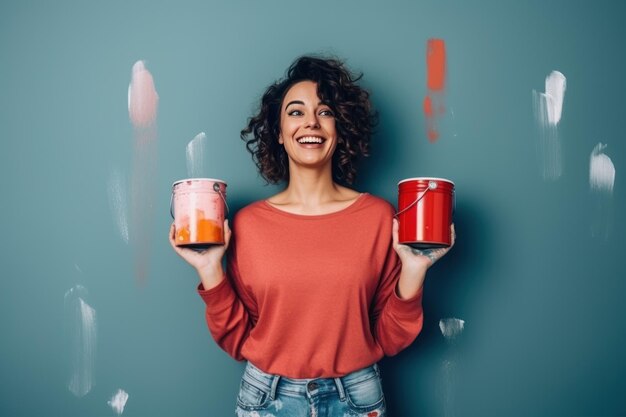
xmin=64 ymin=285 xmax=97 ymax=397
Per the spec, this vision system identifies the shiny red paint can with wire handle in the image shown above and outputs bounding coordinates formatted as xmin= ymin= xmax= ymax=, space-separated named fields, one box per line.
xmin=396 ymin=177 xmax=455 ymax=249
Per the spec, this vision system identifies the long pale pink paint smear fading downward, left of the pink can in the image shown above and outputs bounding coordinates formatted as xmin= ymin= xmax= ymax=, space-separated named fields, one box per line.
xmin=128 ymin=61 xmax=159 ymax=283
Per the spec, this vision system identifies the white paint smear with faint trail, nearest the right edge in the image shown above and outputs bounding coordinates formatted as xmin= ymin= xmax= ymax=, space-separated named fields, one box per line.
xmin=589 ymin=143 xmax=615 ymax=240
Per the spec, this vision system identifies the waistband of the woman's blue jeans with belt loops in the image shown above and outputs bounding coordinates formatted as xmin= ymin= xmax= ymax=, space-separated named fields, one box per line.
xmin=243 ymin=362 xmax=380 ymax=401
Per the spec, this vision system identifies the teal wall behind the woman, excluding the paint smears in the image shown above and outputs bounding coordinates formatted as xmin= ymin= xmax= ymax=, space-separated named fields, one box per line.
xmin=0 ymin=0 xmax=626 ymax=417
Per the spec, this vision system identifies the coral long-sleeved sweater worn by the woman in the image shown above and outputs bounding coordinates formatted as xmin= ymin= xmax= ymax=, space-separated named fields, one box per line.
xmin=198 ymin=194 xmax=423 ymax=378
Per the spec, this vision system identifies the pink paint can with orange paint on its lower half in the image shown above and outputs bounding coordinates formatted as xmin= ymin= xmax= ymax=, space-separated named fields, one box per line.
xmin=170 ymin=178 xmax=228 ymax=249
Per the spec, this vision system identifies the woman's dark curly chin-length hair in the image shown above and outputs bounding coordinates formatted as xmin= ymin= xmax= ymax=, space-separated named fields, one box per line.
xmin=241 ymin=56 xmax=378 ymax=184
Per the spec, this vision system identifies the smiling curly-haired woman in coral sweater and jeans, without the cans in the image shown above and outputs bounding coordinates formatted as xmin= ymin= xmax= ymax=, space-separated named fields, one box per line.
xmin=170 ymin=57 xmax=454 ymax=417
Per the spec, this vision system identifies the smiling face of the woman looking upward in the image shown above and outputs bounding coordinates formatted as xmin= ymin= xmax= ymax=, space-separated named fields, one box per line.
xmin=278 ymin=81 xmax=337 ymax=171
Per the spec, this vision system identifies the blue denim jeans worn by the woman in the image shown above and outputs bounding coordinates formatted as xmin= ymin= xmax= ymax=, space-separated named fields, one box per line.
xmin=236 ymin=362 xmax=386 ymax=417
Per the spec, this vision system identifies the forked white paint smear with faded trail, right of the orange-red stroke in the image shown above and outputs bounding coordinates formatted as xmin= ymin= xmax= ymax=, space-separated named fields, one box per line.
xmin=532 ymin=71 xmax=567 ymax=180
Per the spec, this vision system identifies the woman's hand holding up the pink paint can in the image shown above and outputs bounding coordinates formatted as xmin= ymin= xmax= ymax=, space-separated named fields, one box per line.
xmin=169 ymin=220 xmax=232 ymax=287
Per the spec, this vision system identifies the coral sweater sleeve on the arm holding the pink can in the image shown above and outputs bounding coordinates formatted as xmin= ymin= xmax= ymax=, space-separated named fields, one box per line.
xmin=198 ymin=232 xmax=258 ymax=360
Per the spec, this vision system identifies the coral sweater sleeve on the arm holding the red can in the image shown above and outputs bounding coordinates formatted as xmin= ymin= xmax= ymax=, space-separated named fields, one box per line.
xmin=370 ymin=214 xmax=424 ymax=356
